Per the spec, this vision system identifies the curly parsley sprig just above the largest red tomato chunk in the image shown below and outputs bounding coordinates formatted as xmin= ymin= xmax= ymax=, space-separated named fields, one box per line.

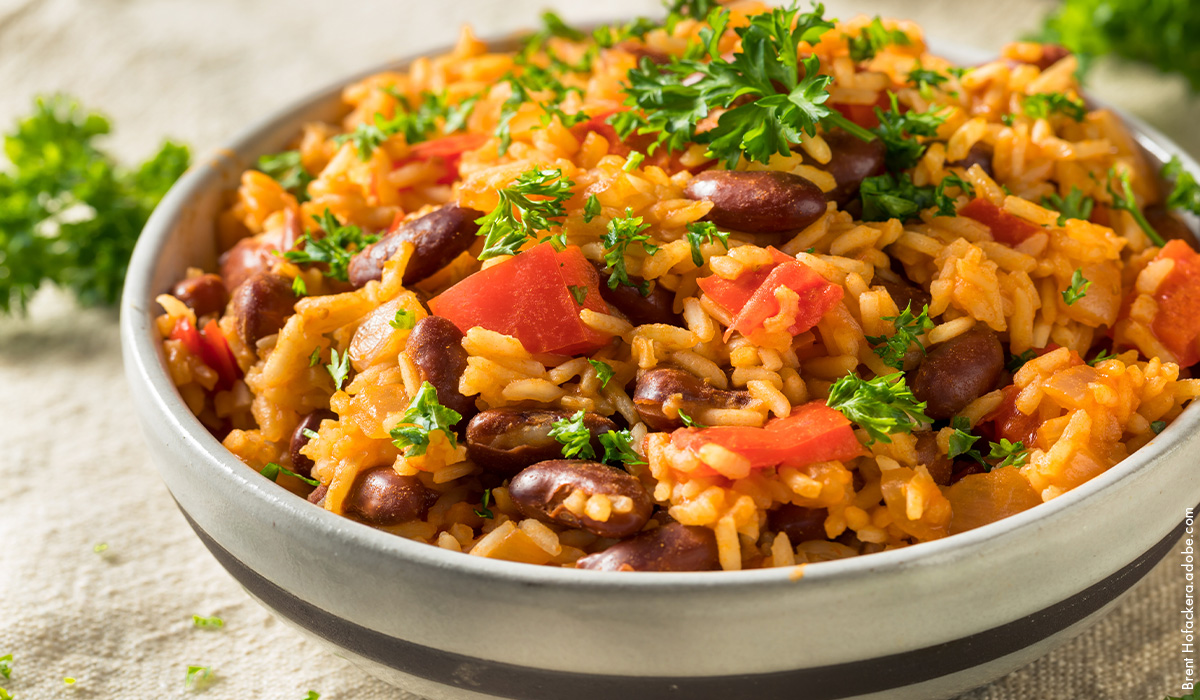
xmin=475 ymin=168 xmax=575 ymax=261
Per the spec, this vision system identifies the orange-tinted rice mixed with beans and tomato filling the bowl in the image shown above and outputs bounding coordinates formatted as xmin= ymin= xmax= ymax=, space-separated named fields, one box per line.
xmin=156 ymin=1 xmax=1200 ymax=570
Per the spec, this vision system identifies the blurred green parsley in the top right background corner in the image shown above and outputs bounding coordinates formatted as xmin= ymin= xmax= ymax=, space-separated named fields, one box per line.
xmin=1034 ymin=0 xmax=1200 ymax=92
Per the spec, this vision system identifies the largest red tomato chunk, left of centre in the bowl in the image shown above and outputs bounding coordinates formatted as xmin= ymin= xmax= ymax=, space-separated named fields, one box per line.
xmin=430 ymin=243 xmax=608 ymax=355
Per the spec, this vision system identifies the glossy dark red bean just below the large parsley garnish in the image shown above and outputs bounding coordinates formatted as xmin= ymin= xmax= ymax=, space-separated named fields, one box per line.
xmin=684 ymin=170 xmax=826 ymax=233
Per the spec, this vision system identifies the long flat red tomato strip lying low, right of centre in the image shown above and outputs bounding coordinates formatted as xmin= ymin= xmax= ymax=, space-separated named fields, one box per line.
xmin=671 ymin=401 xmax=864 ymax=468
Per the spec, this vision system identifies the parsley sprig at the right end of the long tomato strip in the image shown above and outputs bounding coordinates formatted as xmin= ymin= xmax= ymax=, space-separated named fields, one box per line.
xmin=826 ymin=372 xmax=930 ymax=443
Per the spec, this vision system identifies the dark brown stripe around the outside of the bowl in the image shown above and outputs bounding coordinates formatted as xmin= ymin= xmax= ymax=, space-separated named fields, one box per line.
xmin=176 ymin=502 xmax=1200 ymax=700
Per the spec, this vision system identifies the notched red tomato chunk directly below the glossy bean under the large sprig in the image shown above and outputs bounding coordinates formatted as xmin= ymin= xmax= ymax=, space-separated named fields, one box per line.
xmin=696 ymin=247 xmax=842 ymax=340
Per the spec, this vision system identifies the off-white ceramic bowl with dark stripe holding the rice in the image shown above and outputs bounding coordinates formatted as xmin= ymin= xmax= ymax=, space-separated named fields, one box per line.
xmin=121 ymin=34 xmax=1200 ymax=700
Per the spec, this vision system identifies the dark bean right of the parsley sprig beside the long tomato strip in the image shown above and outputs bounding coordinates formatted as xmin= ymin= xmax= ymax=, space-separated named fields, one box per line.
xmin=912 ymin=325 xmax=1004 ymax=420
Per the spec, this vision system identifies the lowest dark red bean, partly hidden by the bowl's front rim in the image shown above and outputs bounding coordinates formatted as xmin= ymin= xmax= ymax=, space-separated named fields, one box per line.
xmin=575 ymin=522 xmax=720 ymax=572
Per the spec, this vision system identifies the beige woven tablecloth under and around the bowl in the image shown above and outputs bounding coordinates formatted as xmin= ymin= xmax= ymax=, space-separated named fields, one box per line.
xmin=0 ymin=0 xmax=1200 ymax=700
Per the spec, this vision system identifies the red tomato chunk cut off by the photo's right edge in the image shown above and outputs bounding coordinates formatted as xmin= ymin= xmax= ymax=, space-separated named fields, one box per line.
xmin=1151 ymin=240 xmax=1200 ymax=367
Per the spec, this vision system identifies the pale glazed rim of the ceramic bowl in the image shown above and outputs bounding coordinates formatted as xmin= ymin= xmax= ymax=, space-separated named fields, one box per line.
xmin=120 ymin=31 xmax=1200 ymax=592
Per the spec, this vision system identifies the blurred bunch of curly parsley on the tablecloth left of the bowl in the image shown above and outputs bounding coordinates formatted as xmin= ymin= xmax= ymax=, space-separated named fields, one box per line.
xmin=0 ymin=95 xmax=190 ymax=313
